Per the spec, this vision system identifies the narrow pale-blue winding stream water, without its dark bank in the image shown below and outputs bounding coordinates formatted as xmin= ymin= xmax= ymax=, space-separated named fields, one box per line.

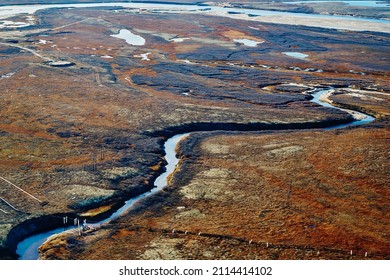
xmin=16 ymin=88 xmax=374 ymax=260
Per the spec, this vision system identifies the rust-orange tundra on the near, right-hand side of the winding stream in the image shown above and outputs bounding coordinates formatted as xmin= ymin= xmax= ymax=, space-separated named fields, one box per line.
xmin=37 ymin=121 xmax=390 ymax=259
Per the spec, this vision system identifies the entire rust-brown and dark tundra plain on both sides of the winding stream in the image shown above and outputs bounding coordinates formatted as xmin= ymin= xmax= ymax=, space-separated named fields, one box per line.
xmin=0 ymin=0 xmax=390 ymax=259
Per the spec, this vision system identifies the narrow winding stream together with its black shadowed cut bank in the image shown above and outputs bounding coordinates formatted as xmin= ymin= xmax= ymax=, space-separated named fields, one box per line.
xmin=4 ymin=85 xmax=374 ymax=259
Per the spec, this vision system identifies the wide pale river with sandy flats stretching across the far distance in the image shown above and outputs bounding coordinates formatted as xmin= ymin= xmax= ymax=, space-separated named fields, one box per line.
xmin=0 ymin=1 xmax=390 ymax=33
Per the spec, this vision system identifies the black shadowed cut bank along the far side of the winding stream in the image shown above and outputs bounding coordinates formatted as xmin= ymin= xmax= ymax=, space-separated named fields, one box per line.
xmin=7 ymin=111 xmax=352 ymax=258
